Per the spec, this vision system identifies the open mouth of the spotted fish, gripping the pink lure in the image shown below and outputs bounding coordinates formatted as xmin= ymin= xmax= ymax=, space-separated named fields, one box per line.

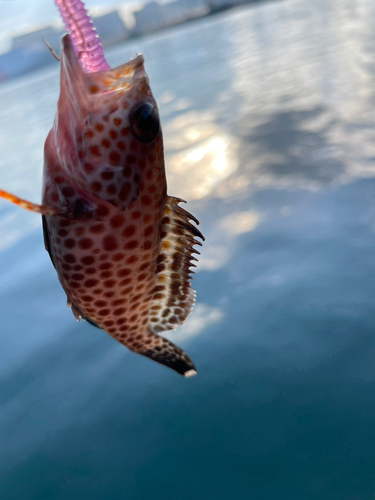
xmin=61 ymin=35 xmax=148 ymax=99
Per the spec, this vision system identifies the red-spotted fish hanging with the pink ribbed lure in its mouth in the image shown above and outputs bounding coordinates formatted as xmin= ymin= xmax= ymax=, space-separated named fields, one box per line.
xmin=0 ymin=0 xmax=204 ymax=377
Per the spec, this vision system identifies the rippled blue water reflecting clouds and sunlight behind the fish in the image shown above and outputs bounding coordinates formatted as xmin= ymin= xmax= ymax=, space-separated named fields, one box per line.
xmin=0 ymin=0 xmax=375 ymax=500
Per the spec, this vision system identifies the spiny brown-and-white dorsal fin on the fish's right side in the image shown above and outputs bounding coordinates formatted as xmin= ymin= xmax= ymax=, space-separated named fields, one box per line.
xmin=149 ymin=196 xmax=204 ymax=332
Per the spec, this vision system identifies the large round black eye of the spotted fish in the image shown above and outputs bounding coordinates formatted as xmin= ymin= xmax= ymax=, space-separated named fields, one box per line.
xmin=130 ymin=102 xmax=160 ymax=142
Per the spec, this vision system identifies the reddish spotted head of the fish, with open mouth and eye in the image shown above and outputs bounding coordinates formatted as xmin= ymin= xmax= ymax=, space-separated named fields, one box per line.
xmin=45 ymin=35 xmax=166 ymax=208
